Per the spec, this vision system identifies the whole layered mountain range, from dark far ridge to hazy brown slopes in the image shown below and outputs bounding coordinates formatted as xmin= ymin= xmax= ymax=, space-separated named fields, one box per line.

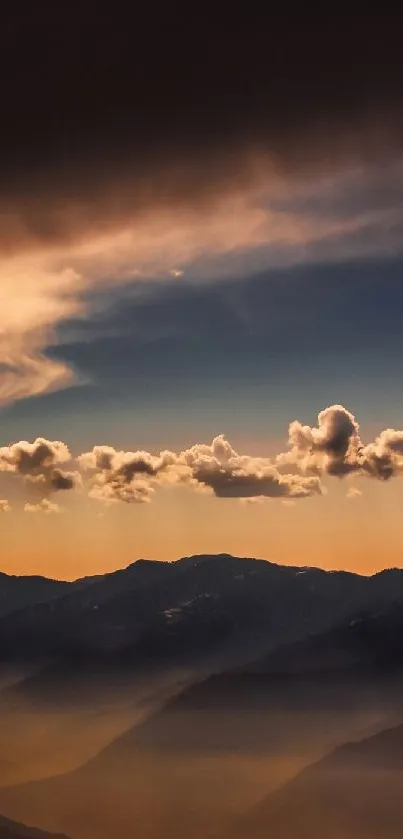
xmin=0 ymin=554 xmax=403 ymax=839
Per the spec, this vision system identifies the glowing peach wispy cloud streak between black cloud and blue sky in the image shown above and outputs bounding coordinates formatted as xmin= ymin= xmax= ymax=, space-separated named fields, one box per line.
xmin=0 ymin=159 xmax=403 ymax=405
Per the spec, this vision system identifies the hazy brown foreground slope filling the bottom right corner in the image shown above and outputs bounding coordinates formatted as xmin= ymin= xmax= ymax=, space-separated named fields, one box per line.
xmin=222 ymin=726 xmax=403 ymax=839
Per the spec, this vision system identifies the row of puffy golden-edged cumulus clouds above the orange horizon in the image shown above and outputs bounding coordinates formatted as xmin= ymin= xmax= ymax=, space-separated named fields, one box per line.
xmin=0 ymin=405 xmax=403 ymax=513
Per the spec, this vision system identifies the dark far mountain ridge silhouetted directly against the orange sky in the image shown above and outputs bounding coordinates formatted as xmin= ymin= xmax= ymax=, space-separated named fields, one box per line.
xmin=0 ymin=554 xmax=403 ymax=696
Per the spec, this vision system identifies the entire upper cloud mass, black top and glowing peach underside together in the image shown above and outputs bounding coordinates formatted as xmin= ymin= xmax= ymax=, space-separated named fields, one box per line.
xmin=0 ymin=11 xmax=403 ymax=405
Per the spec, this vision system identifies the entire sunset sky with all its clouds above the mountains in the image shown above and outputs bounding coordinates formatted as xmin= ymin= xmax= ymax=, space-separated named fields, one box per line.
xmin=0 ymin=11 xmax=403 ymax=579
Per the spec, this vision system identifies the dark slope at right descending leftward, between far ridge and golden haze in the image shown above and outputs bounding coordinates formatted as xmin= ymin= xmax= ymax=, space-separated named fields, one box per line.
xmin=171 ymin=601 xmax=403 ymax=711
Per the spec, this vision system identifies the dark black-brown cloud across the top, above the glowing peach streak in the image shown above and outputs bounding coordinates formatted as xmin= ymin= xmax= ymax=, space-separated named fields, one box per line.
xmin=0 ymin=9 xmax=401 ymax=253
